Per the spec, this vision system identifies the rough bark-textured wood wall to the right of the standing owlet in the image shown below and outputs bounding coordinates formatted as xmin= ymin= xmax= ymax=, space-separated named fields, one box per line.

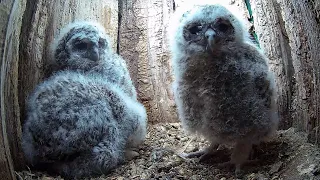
xmin=253 ymin=0 xmax=320 ymax=141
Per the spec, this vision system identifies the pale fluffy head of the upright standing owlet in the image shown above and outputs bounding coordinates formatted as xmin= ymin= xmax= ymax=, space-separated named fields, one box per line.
xmin=170 ymin=4 xmax=245 ymax=52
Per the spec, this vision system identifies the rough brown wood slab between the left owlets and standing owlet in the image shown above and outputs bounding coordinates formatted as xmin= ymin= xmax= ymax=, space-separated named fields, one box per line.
xmin=118 ymin=0 xmax=177 ymax=123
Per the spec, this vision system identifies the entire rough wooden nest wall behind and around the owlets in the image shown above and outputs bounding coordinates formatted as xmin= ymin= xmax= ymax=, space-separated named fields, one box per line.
xmin=0 ymin=0 xmax=320 ymax=179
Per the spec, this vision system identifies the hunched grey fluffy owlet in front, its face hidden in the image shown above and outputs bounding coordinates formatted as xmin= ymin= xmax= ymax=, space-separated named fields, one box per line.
xmin=22 ymin=71 xmax=146 ymax=179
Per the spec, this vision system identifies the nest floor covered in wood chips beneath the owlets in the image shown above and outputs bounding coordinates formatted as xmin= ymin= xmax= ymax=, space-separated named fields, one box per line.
xmin=17 ymin=123 xmax=320 ymax=180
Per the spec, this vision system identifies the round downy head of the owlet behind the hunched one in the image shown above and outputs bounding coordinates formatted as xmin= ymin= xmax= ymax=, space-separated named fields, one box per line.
xmin=52 ymin=21 xmax=111 ymax=71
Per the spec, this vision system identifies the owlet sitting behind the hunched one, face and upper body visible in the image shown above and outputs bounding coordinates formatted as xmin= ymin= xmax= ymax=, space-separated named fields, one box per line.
xmin=47 ymin=21 xmax=137 ymax=98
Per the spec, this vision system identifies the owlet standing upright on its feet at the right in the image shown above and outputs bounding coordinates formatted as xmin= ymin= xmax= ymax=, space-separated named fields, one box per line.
xmin=169 ymin=4 xmax=278 ymax=174
